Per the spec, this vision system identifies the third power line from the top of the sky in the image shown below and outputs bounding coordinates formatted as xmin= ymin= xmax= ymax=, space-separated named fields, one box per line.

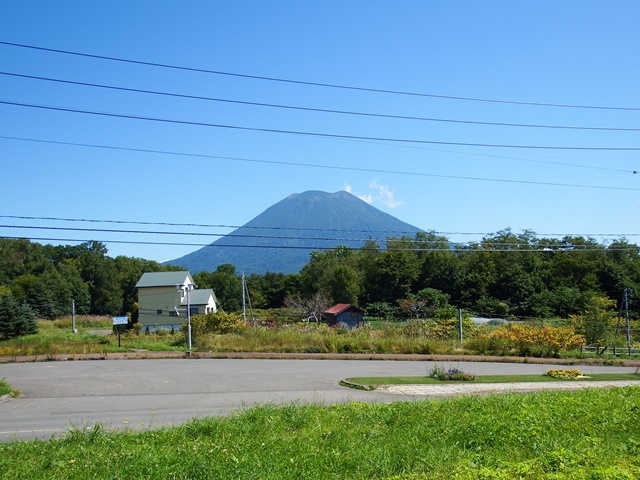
xmin=0 ymin=100 xmax=640 ymax=152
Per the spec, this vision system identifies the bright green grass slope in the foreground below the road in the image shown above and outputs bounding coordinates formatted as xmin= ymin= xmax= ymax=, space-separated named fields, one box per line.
xmin=0 ymin=387 xmax=640 ymax=480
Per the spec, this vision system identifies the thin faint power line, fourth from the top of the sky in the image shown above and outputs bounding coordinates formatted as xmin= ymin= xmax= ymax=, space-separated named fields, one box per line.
xmin=0 ymin=135 xmax=638 ymax=191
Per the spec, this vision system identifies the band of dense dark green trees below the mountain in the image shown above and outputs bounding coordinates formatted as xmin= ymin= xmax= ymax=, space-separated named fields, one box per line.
xmin=0 ymin=229 xmax=640 ymax=320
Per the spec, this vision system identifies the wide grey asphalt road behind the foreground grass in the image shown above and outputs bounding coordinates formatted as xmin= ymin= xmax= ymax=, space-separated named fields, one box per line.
xmin=0 ymin=359 xmax=634 ymax=441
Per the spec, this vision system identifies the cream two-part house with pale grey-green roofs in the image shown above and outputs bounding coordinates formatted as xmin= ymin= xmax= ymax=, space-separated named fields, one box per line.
xmin=136 ymin=271 xmax=217 ymax=330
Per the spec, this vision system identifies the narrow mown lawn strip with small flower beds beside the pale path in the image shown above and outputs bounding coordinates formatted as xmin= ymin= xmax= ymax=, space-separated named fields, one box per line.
xmin=345 ymin=373 xmax=640 ymax=387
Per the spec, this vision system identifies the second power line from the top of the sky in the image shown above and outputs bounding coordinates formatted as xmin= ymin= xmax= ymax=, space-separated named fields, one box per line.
xmin=0 ymin=71 xmax=640 ymax=132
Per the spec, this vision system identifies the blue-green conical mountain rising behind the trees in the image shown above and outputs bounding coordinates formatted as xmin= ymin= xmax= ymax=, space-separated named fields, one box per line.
xmin=166 ymin=191 xmax=421 ymax=275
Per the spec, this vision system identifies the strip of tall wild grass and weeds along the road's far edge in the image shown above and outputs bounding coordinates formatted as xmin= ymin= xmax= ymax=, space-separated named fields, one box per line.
xmin=0 ymin=317 xmax=627 ymax=362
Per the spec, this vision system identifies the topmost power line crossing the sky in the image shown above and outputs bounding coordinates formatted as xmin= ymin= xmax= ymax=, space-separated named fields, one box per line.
xmin=0 ymin=41 xmax=640 ymax=111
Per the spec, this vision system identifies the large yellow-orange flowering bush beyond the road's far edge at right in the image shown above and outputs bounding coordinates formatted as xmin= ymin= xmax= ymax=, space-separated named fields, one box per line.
xmin=476 ymin=323 xmax=584 ymax=357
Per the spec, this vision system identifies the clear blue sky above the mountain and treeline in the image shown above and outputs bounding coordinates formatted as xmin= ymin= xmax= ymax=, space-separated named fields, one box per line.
xmin=0 ymin=0 xmax=640 ymax=261
